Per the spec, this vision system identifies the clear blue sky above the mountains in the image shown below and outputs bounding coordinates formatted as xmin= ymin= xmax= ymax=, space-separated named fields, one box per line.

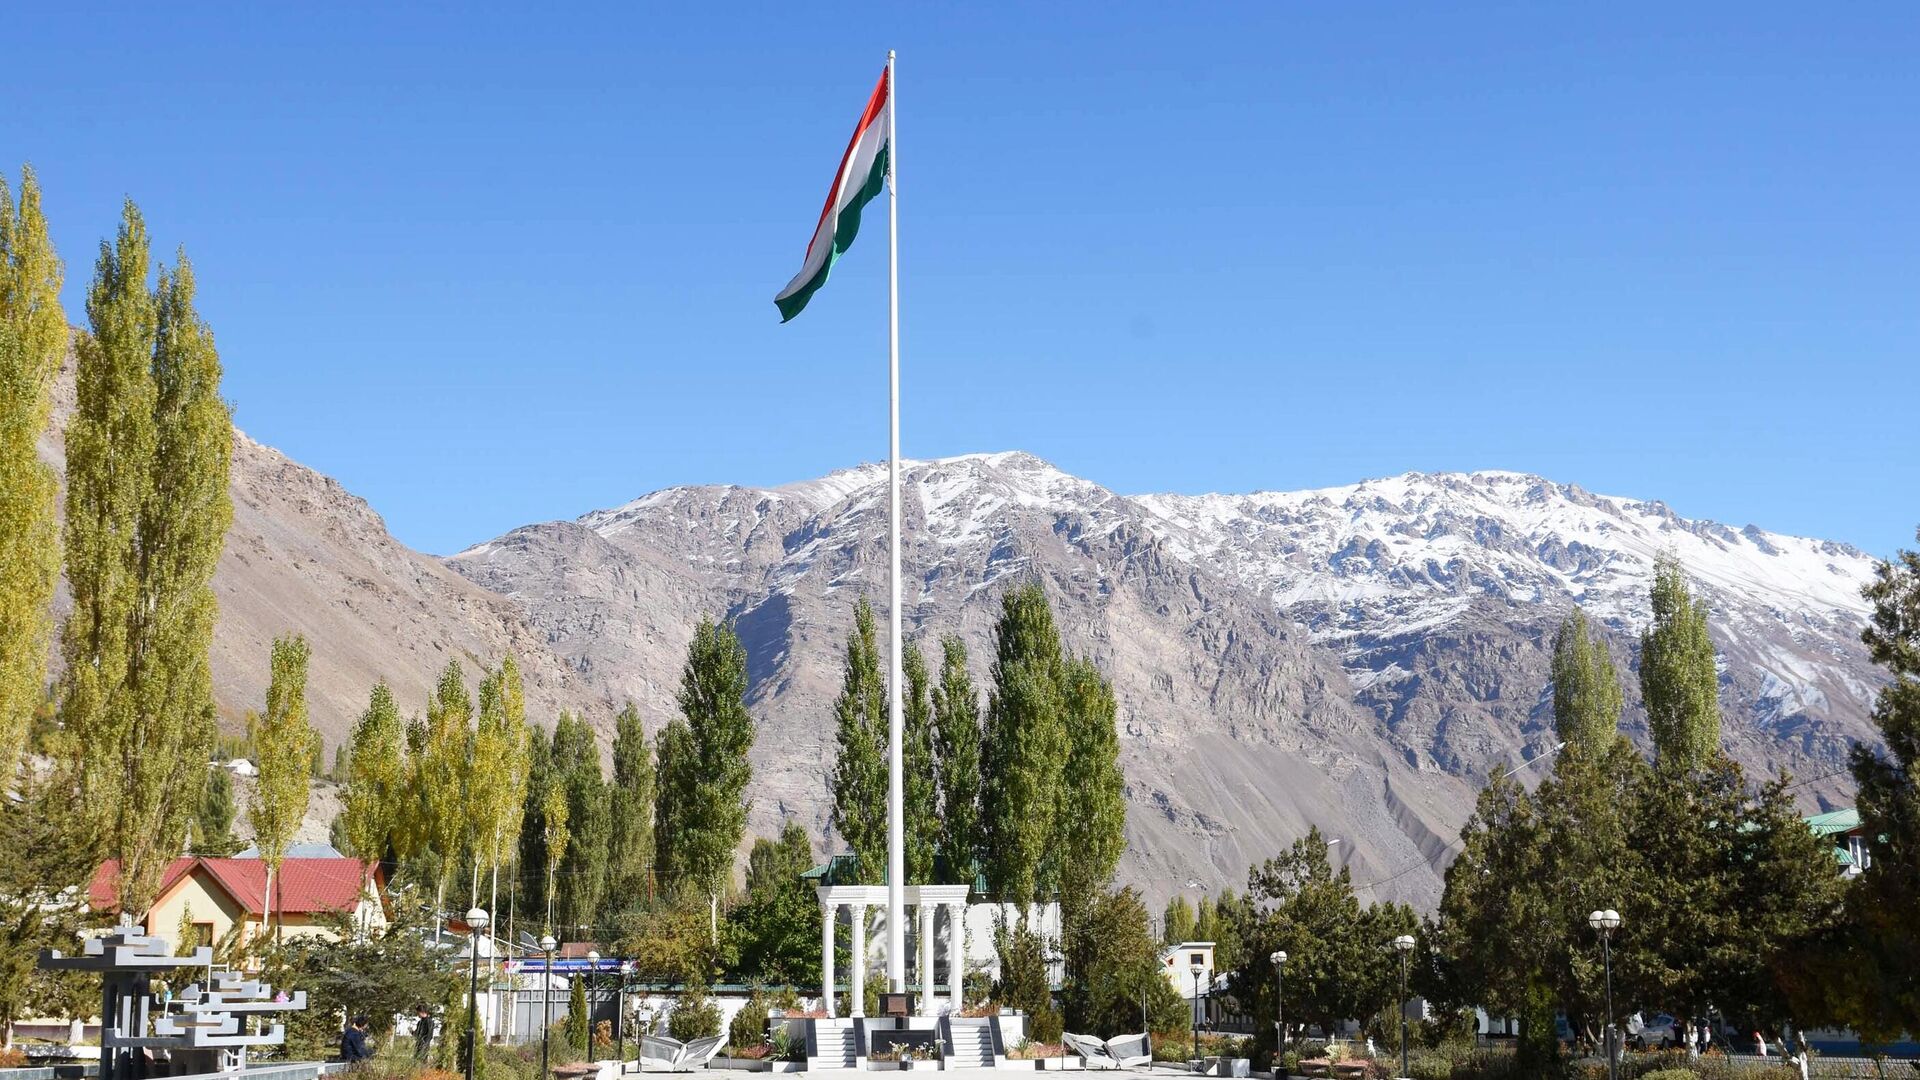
xmin=0 ymin=2 xmax=1920 ymax=553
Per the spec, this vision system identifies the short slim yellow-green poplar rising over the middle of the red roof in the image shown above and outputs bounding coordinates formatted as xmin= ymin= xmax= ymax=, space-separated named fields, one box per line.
xmin=248 ymin=634 xmax=313 ymax=930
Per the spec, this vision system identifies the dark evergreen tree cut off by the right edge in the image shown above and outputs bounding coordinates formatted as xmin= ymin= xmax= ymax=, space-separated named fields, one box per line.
xmin=1841 ymin=532 xmax=1920 ymax=1040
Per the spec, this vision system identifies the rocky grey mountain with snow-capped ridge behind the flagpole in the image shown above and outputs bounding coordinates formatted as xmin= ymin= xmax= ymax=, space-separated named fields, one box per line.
xmin=449 ymin=452 xmax=1880 ymax=901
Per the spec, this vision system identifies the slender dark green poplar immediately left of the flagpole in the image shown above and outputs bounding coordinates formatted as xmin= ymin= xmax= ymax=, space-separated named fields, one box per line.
xmin=829 ymin=596 xmax=887 ymax=884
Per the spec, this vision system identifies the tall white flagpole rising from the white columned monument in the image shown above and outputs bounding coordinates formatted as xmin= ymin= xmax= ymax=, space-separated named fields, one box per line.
xmin=887 ymin=48 xmax=906 ymax=994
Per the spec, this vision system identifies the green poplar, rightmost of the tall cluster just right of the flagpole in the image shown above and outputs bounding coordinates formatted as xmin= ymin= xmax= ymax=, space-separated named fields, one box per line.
xmin=1056 ymin=657 xmax=1127 ymax=897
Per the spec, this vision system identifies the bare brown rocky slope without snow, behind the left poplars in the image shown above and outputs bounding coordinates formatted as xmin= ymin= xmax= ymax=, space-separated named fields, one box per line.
xmin=40 ymin=354 xmax=605 ymax=745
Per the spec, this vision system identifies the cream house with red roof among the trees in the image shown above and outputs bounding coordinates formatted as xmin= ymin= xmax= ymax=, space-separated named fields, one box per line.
xmin=86 ymin=853 xmax=388 ymax=945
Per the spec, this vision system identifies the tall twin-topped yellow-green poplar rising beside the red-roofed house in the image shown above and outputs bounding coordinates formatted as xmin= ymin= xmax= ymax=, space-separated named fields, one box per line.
xmin=60 ymin=202 xmax=232 ymax=911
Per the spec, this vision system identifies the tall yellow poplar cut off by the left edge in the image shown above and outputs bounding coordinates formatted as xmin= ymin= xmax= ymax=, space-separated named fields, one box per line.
xmin=0 ymin=167 xmax=67 ymax=778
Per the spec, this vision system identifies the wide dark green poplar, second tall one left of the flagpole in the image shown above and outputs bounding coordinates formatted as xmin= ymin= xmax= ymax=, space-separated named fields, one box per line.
xmin=655 ymin=619 xmax=753 ymax=936
